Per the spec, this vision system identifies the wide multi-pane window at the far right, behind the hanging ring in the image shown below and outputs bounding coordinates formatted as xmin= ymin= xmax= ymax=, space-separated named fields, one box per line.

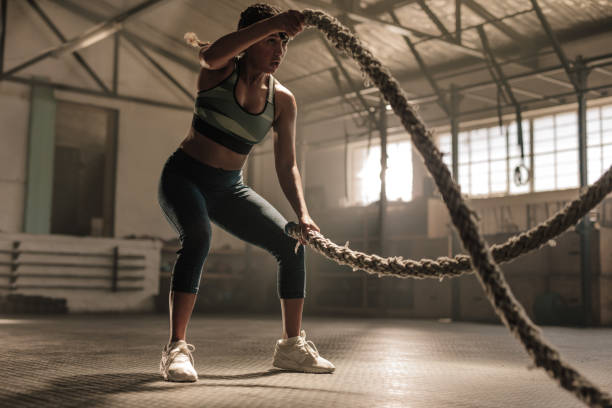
xmin=438 ymin=105 xmax=612 ymax=196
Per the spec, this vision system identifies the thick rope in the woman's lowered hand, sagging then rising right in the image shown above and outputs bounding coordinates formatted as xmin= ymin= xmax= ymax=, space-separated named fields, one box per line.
xmin=287 ymin=163 xmax=612 ymax=280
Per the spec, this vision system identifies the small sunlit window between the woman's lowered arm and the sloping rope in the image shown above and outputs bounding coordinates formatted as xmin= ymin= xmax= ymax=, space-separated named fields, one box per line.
xmin=348 ymin=140 xmax=412 ymax=205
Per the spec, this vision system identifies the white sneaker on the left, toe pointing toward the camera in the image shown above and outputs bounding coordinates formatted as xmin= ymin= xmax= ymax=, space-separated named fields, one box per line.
xmin=159 ymin=340 xmax=198 ymax=382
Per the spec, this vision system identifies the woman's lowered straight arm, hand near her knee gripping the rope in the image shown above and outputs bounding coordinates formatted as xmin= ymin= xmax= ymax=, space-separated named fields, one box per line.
xmin=274 ymin=88 xmax=320 ymax=244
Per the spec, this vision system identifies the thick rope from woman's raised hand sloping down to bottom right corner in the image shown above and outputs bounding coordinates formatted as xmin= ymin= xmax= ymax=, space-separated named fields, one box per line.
xmin=303 ymin=10 xmax=612 ymax=407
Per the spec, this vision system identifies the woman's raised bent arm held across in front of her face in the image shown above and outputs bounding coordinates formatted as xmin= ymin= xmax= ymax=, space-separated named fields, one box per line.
xmin=200 ymin=10 xmax=304 ymax=70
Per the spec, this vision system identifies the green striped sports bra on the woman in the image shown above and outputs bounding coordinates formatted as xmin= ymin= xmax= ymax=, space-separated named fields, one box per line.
xmin=192 ymin=59 xmax=275 ymax=154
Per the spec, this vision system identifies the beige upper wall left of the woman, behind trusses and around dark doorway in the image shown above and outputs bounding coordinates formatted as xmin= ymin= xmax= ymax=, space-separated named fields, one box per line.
xmin=0 ymin=2 xmax=250 ymax=252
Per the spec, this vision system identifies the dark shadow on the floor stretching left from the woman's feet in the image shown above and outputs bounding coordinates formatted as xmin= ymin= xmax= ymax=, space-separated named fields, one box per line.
xmin=0 ymin=369 xmax=344 ymax=407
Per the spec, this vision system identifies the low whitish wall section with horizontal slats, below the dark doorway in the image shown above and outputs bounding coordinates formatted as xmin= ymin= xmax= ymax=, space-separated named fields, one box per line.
xmin=0 ymin=233 xmax=161 ymax=312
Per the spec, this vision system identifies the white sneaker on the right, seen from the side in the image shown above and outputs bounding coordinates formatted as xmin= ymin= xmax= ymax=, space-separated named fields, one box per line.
xmin=272 ymin=330 xmax=336 ymax=373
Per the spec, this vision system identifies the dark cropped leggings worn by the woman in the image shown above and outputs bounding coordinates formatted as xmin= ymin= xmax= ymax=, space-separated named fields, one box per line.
xmin=158 ymin=149 xmax=306 ymax=299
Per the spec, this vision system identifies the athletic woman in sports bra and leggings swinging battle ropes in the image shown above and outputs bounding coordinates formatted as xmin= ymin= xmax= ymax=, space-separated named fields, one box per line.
xmin=159 ymin=4 xmax=335 ymax=381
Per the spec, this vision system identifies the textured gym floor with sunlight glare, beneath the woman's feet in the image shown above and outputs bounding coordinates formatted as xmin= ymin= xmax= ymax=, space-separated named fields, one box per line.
xmin=0 ymin=314 xmax=612 ymax=408
